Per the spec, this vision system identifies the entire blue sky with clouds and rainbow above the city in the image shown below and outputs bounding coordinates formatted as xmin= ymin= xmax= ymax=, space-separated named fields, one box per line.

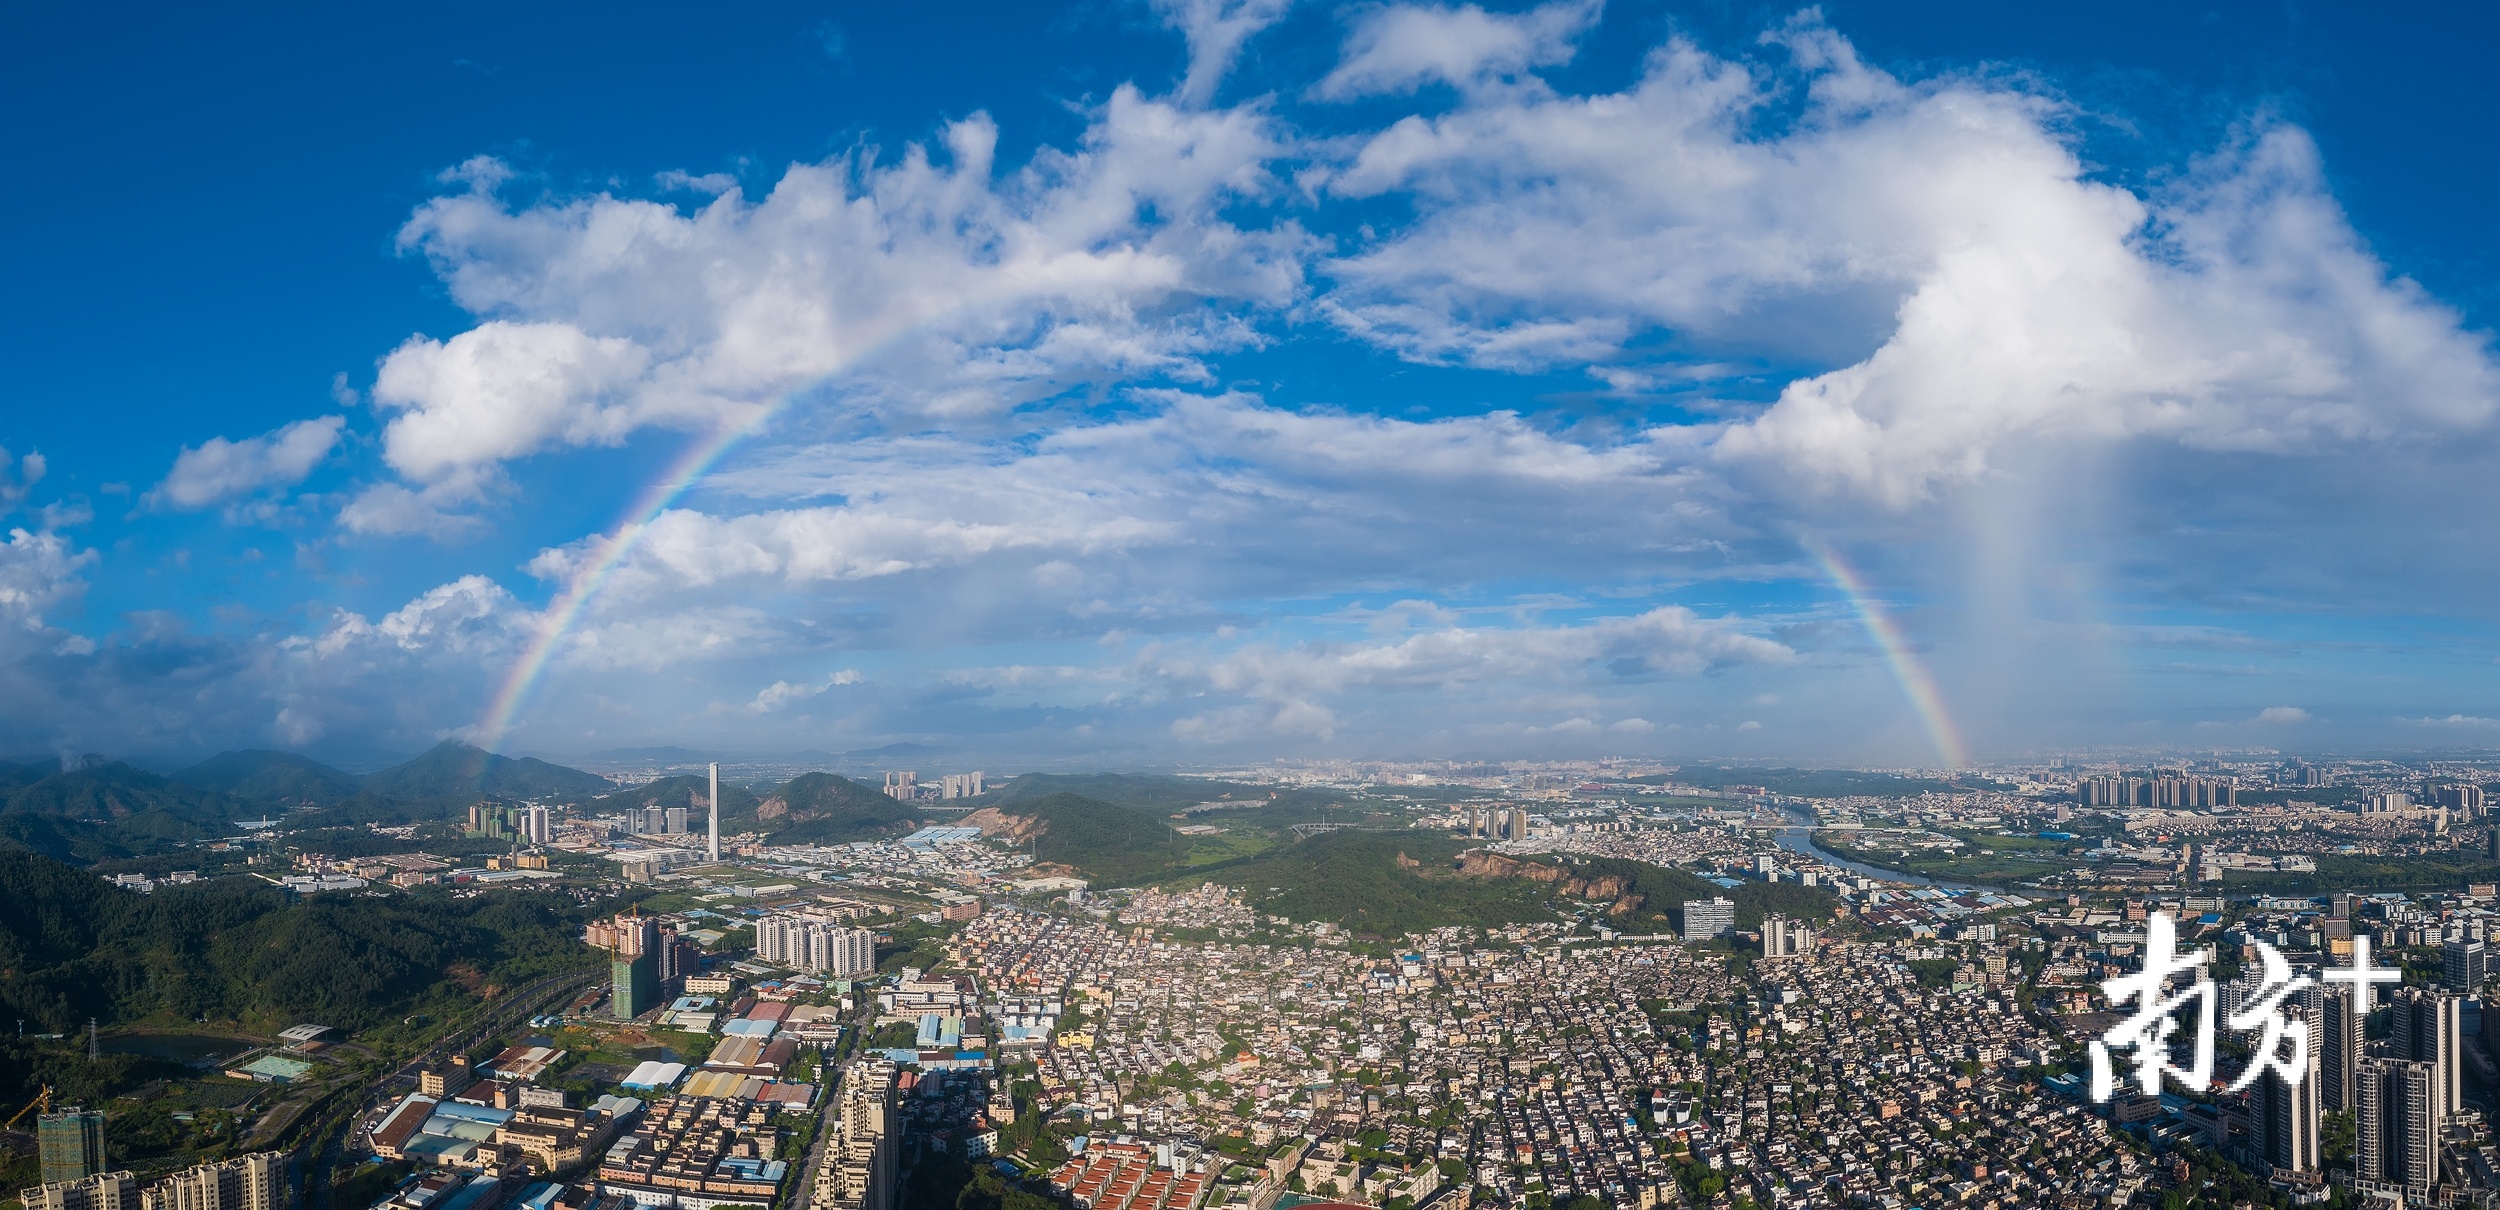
xmin=0 ymin=0 xmax=2500 ymax=765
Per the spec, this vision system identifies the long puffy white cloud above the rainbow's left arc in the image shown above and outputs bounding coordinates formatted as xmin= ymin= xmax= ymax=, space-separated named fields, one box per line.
xmin=375 ymin=91 xmax=1310 ymax=483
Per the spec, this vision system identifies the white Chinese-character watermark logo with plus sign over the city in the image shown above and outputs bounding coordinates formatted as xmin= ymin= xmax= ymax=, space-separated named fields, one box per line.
xmin=2090 ymin=913 xmax=2403 ymax=1100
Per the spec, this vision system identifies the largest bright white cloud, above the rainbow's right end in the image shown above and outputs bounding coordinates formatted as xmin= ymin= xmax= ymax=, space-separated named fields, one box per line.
xmin=1325 ymin=20 xmax=2500 ymax=505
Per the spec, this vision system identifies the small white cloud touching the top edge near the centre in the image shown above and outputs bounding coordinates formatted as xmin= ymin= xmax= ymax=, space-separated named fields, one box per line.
xmin=1313 ymin=0 xmax=1603 ymax=100
